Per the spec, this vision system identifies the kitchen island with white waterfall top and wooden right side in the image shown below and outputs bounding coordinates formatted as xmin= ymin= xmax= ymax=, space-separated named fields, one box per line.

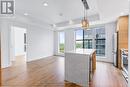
xmin=65 ymin=49 xmax=96 ymax=87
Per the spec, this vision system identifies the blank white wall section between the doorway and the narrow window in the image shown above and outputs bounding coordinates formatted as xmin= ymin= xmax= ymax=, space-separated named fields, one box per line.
xmin=27 ymin=26 xmax=54 ymax=61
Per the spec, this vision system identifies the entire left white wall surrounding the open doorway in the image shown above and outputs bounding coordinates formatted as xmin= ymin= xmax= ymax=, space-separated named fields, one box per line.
xmin=0 ymin=17 xmax=53 ymax=68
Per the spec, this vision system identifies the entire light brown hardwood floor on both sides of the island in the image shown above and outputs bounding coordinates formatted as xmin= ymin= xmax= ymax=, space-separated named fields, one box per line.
xmin=0 ymin=56 xmax=127 ymax=87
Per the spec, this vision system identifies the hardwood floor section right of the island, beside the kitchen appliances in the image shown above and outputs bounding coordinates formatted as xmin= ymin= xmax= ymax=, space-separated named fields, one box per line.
xmin=90 ymin=62 xmax=127 ymax=87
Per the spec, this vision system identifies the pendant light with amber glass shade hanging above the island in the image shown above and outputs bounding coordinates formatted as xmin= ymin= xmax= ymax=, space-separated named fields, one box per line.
xmin=81 ymin=2 xmax=89 ymax=30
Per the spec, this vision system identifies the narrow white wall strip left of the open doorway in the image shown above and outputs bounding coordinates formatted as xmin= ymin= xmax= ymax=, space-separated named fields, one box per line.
xmin=0 ymin=20 xmax=11 ymax=68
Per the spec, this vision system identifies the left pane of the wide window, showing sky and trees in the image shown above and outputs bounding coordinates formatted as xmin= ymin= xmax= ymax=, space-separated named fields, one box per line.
xmin=76 ymin=29 xmax=83 ymax=49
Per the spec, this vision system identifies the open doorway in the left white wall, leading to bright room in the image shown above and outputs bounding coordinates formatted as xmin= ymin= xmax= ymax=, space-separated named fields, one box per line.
xmin=10 ymin=26 xmax=27 ymax=65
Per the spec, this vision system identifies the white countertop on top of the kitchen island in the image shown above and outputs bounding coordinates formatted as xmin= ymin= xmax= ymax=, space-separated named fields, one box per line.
xmin=66 ymin=49 xmax=96 ymax=55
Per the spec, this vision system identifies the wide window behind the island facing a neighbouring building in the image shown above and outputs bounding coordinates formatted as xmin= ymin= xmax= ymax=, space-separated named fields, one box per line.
xmin=75 ymin=27 xmax=106 ymax=56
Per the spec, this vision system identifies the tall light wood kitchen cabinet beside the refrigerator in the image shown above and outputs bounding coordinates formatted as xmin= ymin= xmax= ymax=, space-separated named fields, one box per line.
xmin=117 ymin=16 xmax=128 ymax=69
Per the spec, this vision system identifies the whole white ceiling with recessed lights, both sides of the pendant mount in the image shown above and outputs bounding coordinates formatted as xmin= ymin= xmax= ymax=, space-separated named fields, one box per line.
xmin=15 ymin=0 xmax=128 ymax=24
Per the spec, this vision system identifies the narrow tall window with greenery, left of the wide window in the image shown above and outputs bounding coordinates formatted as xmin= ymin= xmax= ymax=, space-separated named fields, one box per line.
xmin=59 ymin=32 xmax=65 ymax=53
